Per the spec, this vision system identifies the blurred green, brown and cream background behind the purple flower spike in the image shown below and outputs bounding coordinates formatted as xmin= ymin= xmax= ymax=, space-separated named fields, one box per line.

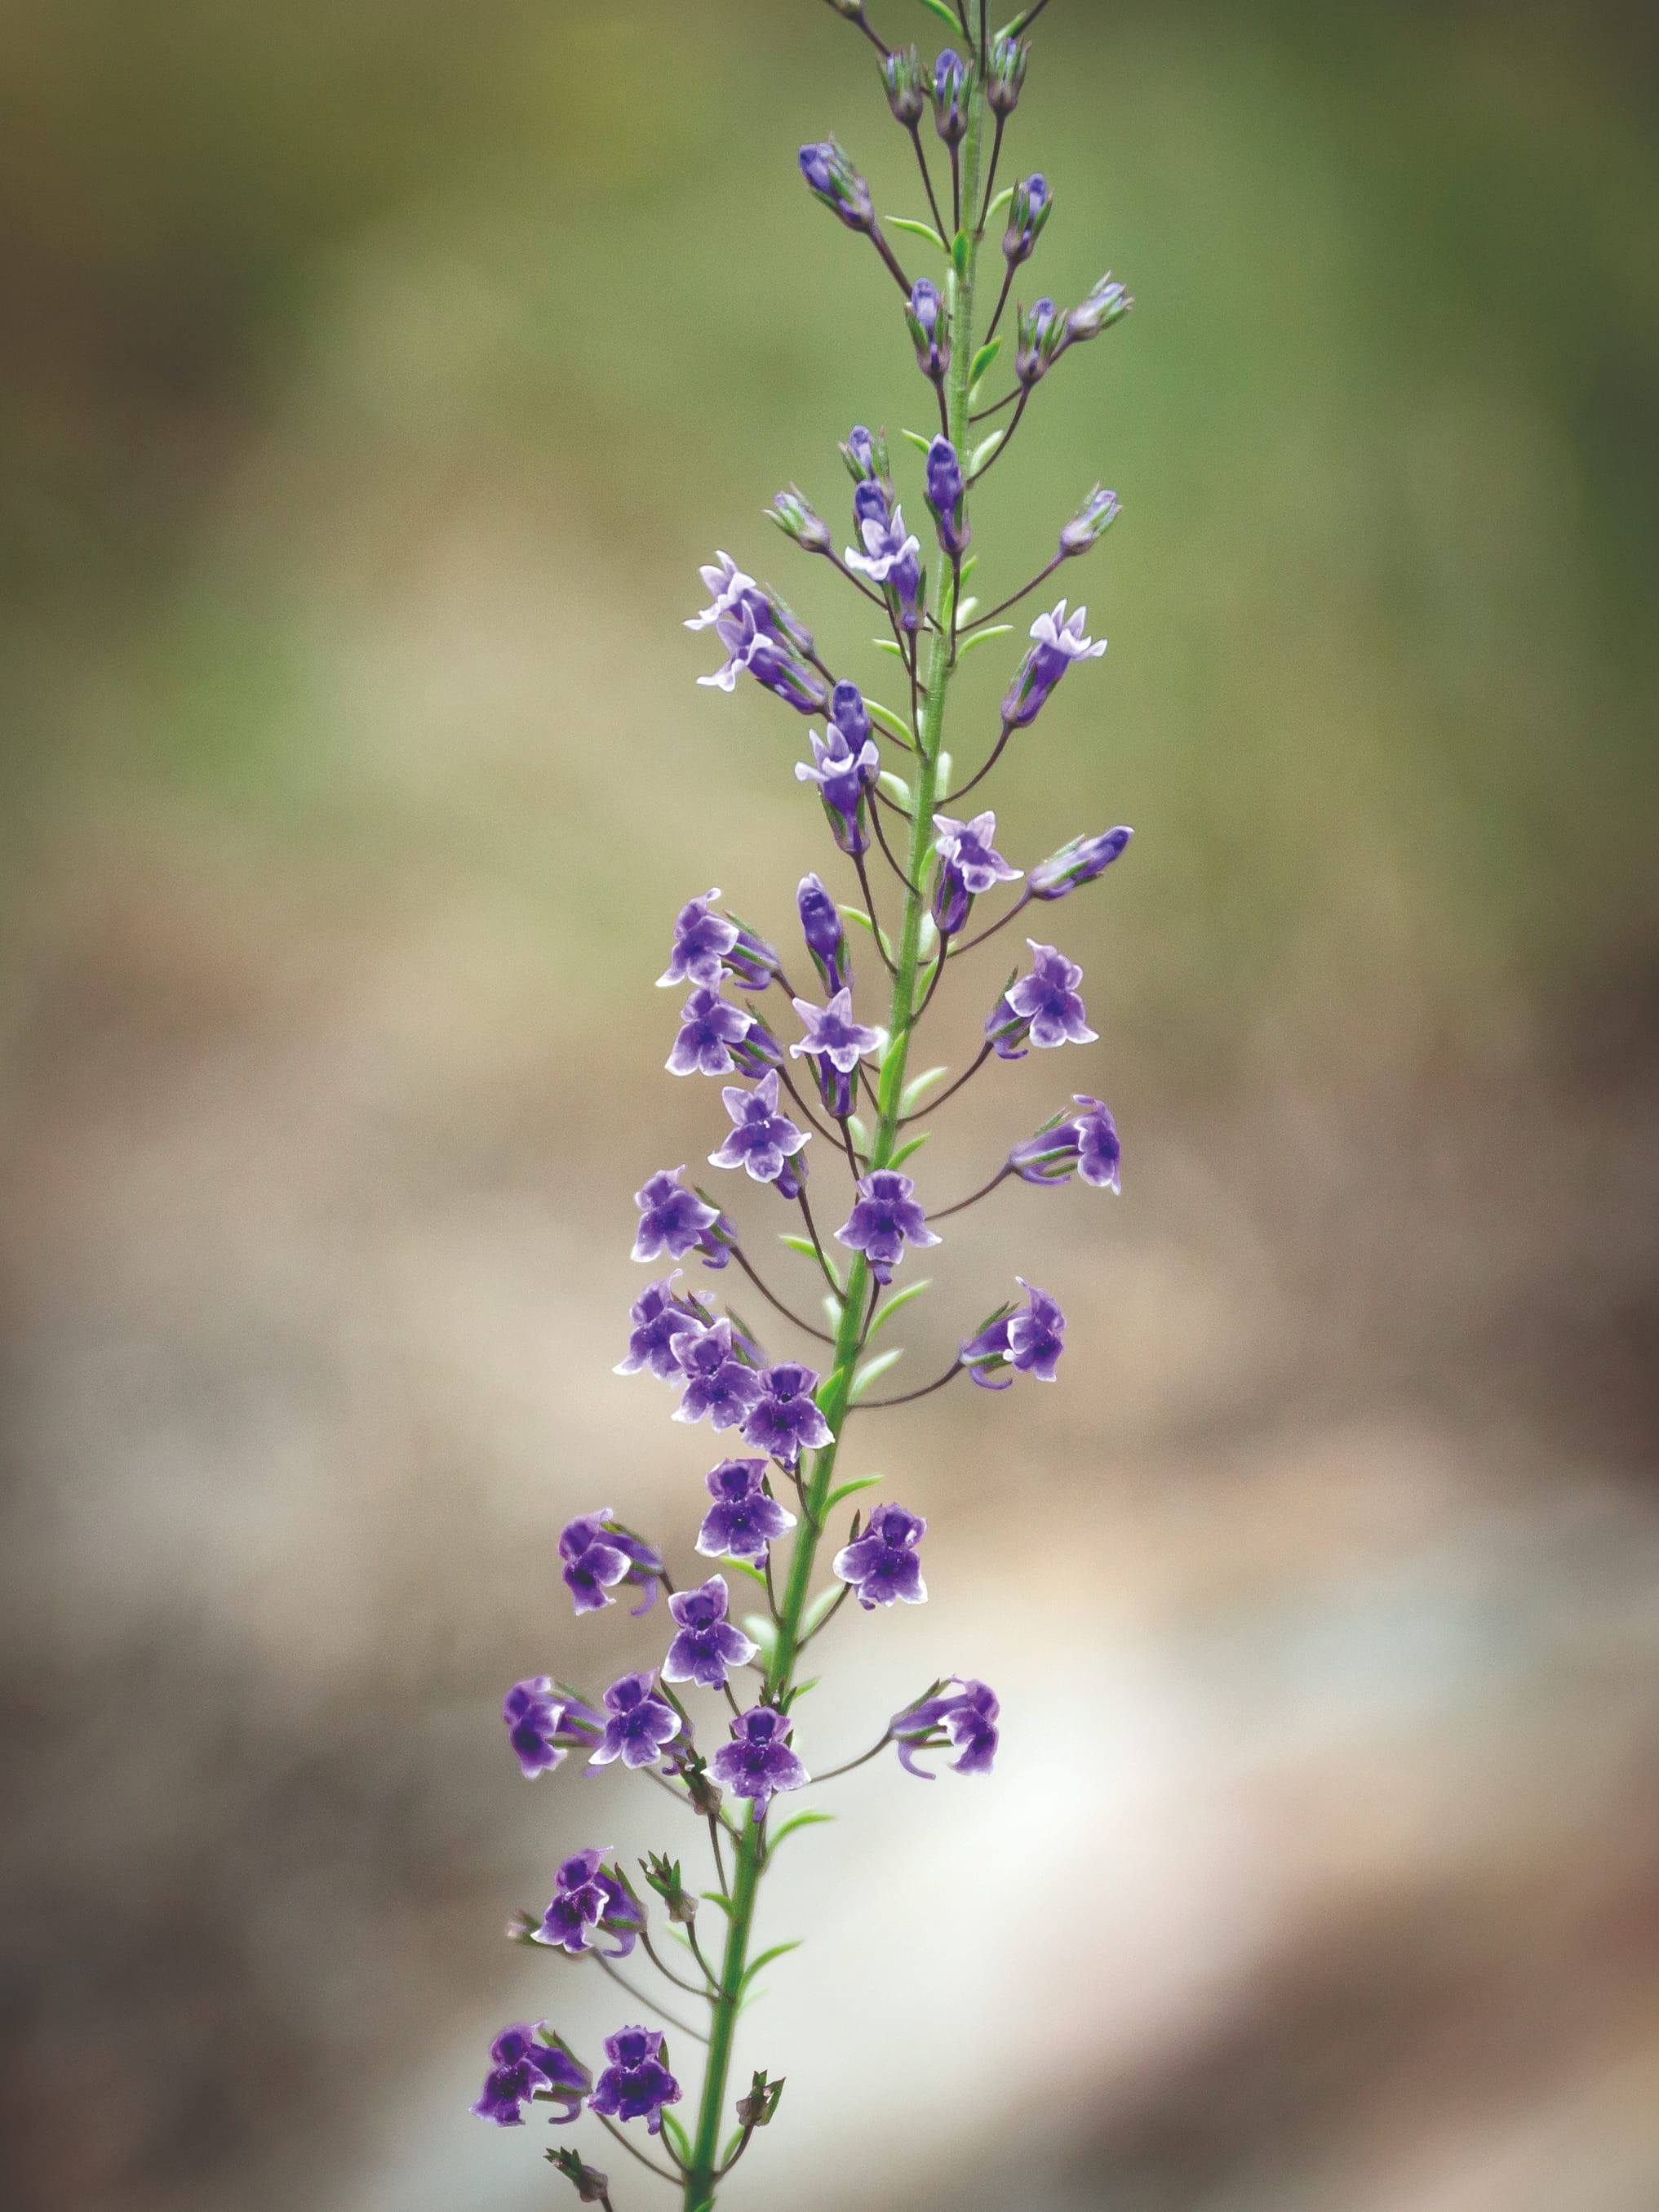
xmin=0 ymin=0 xmax=1659 ymax=2212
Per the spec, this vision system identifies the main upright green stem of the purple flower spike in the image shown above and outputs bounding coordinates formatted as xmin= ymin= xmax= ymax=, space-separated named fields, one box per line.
xmin=685 ymin=75 xmax=984 ymax=2212
